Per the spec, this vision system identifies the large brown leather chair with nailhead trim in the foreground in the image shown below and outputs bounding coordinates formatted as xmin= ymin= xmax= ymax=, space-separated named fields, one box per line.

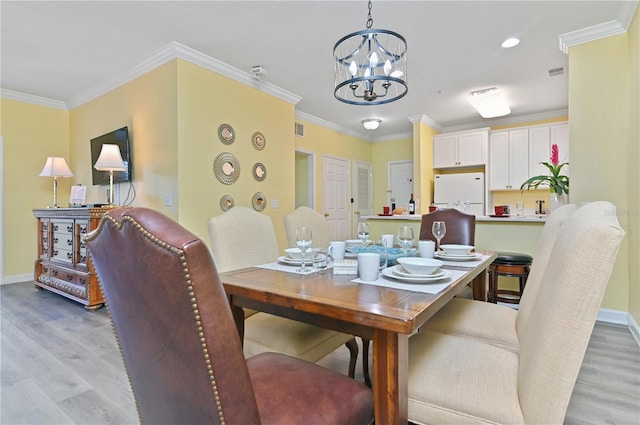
xmin=86 ymin=208 xmax=373 ymax=425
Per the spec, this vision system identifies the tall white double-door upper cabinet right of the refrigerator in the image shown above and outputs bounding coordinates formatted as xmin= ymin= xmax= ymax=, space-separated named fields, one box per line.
xmin=488 ymin=129 xmax=529 ymax=190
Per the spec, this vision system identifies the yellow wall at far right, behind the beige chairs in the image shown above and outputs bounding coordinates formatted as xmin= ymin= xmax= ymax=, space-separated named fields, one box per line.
xmin=569 ymin=32 xmax=639 ymax=311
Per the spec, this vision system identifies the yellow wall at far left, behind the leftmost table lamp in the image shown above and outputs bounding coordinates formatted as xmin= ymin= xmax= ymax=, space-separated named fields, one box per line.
xmin=1 ymin=99 xmax=70 ymax=277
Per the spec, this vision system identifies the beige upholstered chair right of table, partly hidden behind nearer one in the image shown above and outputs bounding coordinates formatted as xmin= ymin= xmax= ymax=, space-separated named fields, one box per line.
xmin=422 ymin=204 xmax=576 ymax=352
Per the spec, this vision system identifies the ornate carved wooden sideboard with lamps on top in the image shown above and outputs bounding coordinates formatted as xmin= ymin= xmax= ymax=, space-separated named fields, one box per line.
xmin=33 ymin=208 xmax=109 ymax=310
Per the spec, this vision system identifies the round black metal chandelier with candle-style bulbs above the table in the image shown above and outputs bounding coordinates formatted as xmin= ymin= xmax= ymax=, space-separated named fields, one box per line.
xmin=333 ymin=1 xmax=408 ymax=105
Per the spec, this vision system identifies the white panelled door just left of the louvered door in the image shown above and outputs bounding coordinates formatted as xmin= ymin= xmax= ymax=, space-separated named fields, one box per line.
xmin=322 ymin=155 xmax=351 ymax=240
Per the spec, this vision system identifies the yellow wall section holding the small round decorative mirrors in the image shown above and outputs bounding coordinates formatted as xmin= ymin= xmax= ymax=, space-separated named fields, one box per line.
xmin=178 ymin=61 xmax=295 ymax=245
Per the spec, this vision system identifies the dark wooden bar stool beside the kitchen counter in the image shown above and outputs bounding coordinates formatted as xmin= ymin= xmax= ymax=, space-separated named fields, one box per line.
xmin=487 ymin=252 xmax=533 ymax=304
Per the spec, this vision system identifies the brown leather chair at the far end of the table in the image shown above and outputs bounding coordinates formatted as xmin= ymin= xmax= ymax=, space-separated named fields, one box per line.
xmin=420 ymin=208 xmax=476 ymax=245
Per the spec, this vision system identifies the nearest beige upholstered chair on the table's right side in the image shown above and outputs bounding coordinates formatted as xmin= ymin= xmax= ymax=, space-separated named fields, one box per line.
xmin=408 ymin=202 xmax=624 ymax=424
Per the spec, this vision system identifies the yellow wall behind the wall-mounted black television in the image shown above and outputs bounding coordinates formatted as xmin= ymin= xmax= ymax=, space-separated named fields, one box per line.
xmin=70 ymin=61 xmax=178 ymax=215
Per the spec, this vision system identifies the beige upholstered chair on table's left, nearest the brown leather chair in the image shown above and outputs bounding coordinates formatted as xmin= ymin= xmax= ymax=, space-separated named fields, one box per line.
xmin=208 ymin=206 xmax=358 ymax=377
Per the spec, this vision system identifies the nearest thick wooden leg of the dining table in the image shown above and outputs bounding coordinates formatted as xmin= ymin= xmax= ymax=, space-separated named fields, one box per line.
xmin=373 ymin=329 xmax=409 ymax=425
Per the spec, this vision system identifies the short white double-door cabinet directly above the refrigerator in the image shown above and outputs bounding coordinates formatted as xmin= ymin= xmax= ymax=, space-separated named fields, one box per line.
xmin=433 ymin=128 xmax=489 ymax=169
